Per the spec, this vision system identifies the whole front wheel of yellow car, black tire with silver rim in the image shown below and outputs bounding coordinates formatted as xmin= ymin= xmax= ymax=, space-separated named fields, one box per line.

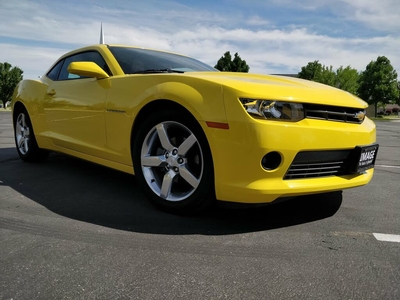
xmin=132 ymin=111 xmax=215 ymax=214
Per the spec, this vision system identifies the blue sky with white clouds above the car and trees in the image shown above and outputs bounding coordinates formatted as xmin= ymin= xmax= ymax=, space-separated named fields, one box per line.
xmin=0 ymin=0 xmax=400 ymax=79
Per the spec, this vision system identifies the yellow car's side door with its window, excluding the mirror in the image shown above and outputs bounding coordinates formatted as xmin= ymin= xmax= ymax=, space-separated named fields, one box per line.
xmin=43 ymin=51 xmax=109 ymax=158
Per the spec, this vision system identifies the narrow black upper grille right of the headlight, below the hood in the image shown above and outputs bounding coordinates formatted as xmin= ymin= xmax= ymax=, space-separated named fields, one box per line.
xmin=304 ymin=104 xmax=365 ymax=124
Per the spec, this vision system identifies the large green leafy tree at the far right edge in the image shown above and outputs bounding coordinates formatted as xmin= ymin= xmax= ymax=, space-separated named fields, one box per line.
xmin=358 ymin=56 xmax=399 ymax=116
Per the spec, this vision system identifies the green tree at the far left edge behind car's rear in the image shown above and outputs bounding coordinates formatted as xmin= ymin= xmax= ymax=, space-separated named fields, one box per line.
xmin=0 ymin=62 xmax=24 ymax=107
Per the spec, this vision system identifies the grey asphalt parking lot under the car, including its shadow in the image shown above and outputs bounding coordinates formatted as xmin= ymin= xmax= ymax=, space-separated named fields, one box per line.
xmin=0 ymin=112 xmax=400 ymax=300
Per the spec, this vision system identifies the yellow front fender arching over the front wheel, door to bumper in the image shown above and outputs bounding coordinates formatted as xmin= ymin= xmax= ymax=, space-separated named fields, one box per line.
xmin=106 ymin=74 xmax=227 ymax=163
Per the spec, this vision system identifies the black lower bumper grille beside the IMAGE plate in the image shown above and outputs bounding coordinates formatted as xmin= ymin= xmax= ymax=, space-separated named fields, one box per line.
xmin=284 ymin=150 xmax=352 ymax=179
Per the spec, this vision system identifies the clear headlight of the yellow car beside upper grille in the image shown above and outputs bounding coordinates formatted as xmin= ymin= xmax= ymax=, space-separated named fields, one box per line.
xmin=240 ymin=98 xmax=304 ymax=122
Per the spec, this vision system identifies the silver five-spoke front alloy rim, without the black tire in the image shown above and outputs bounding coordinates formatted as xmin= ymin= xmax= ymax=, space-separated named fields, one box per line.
xmin=141 ymin=121 xmax=204 ymax=202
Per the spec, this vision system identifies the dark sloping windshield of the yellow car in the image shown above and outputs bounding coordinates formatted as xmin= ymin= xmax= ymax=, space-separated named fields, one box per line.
xmin=109 ymin=46 xmax=217 ymax=74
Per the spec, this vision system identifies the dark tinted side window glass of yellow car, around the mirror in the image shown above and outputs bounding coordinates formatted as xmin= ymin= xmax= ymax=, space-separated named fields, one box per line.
xmin=47 ymin=51 xmax=112 ymax=80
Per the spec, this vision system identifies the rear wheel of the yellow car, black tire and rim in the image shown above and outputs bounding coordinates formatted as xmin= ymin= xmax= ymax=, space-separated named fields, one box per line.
xmin=14 ymin=108 xmax=48 ymax=162
